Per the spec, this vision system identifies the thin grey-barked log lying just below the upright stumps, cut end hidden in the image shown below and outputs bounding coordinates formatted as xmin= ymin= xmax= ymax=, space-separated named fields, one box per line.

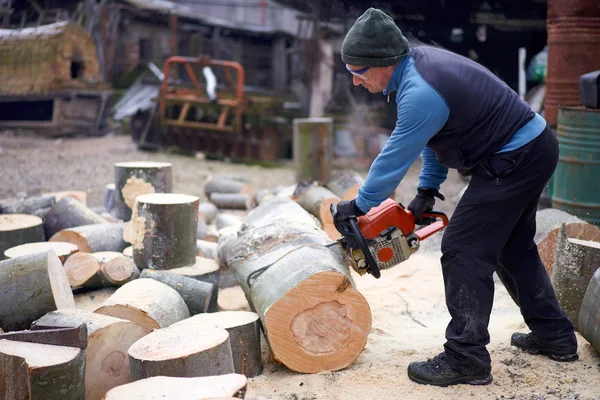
xmin=140 ymin=269 xmax=213 ymax=315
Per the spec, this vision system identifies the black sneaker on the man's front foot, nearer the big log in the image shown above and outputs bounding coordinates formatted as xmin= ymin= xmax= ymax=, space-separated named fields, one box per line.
xmin=408 ymin=352 xmax=493 ymax=386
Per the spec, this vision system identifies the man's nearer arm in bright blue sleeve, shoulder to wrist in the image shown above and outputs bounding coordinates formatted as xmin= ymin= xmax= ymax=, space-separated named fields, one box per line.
xmin=356 ymin=83 xmax=450 ymax=212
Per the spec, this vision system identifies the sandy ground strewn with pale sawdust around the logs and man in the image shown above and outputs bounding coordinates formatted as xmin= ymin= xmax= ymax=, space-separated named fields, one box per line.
xmin=0 ymin=133 xmax=600 ymax=400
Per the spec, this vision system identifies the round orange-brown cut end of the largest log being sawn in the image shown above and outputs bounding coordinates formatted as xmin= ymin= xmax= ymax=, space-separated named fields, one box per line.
xmin=264 ymin=272 xmax=371 ymax=373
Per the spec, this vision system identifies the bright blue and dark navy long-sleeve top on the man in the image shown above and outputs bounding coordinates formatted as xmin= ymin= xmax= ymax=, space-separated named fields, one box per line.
xmin=356 ymin=47 xmax=546 ymax=212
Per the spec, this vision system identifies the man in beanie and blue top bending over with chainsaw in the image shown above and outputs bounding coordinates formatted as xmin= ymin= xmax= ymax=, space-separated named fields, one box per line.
xmin=336 ymin=8 xmax=578 ymax=386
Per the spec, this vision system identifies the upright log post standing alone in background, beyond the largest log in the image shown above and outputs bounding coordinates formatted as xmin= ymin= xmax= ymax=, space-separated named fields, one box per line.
xmin=293 ymin=118 xmax=333 ymax=182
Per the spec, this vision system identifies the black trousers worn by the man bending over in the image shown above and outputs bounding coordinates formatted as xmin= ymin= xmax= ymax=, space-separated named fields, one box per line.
xmin=441 ymin=128 xmax=575 ymax=368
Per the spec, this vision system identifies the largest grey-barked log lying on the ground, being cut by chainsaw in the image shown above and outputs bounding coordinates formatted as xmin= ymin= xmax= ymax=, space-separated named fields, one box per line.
xmin=219 ymin=197 xmax=371 ymax=373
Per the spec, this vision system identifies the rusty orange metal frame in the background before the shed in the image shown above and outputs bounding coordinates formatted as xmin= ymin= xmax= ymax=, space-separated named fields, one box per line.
xmin=159 ymin=56 xmax=248 ymax=133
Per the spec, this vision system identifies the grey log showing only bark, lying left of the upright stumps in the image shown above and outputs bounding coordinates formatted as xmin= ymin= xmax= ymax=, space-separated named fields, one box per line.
xmin=44 ymin=196 xmax=108 ymax=238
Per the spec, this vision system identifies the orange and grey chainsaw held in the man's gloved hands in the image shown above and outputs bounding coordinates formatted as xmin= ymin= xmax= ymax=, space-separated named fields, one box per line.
xmin=329 ymin=199 xmax=448 ymax=278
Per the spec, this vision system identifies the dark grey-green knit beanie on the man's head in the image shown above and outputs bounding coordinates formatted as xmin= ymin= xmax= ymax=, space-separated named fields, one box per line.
xmin=342 ymin=8 xmax=408 ymax=67
